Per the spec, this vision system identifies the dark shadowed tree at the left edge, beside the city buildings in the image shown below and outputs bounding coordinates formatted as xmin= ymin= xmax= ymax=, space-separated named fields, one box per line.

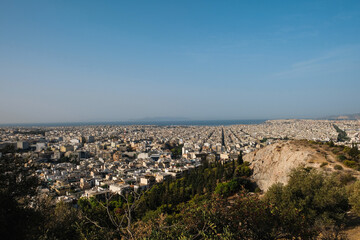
xmin=0 ymin=154 xmax=40 ymax=239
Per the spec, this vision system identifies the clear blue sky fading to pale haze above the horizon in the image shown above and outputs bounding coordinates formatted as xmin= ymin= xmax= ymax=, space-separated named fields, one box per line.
xmin=0 ymin=0 xmax=360 ymax=123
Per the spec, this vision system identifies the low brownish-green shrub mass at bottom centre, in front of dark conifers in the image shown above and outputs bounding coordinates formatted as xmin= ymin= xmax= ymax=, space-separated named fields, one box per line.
xmin=137 ymin=191 xmax=275 ymax=240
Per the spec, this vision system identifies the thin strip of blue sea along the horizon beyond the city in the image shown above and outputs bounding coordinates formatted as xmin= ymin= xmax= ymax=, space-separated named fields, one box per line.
xmin=0 ymin=119 xmax=267 ymax=127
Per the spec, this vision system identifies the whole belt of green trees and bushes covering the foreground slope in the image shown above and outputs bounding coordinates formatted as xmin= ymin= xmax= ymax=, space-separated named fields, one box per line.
xmin=0 ymin=155 xmax=360 ymax=240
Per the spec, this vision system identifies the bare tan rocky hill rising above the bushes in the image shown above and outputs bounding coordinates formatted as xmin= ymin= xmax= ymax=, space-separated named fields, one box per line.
xmin=244 ymin=140 xmax=359 ymax=191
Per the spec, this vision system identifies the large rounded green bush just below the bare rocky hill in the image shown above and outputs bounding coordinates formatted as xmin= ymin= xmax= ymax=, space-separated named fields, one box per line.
xmin=265 ymin=168 xmax=348 ymax=239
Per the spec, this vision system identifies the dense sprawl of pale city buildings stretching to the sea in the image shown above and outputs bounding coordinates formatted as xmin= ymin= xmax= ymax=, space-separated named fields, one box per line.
xmin=0 ymin=120 xmax=360 ymax=202
